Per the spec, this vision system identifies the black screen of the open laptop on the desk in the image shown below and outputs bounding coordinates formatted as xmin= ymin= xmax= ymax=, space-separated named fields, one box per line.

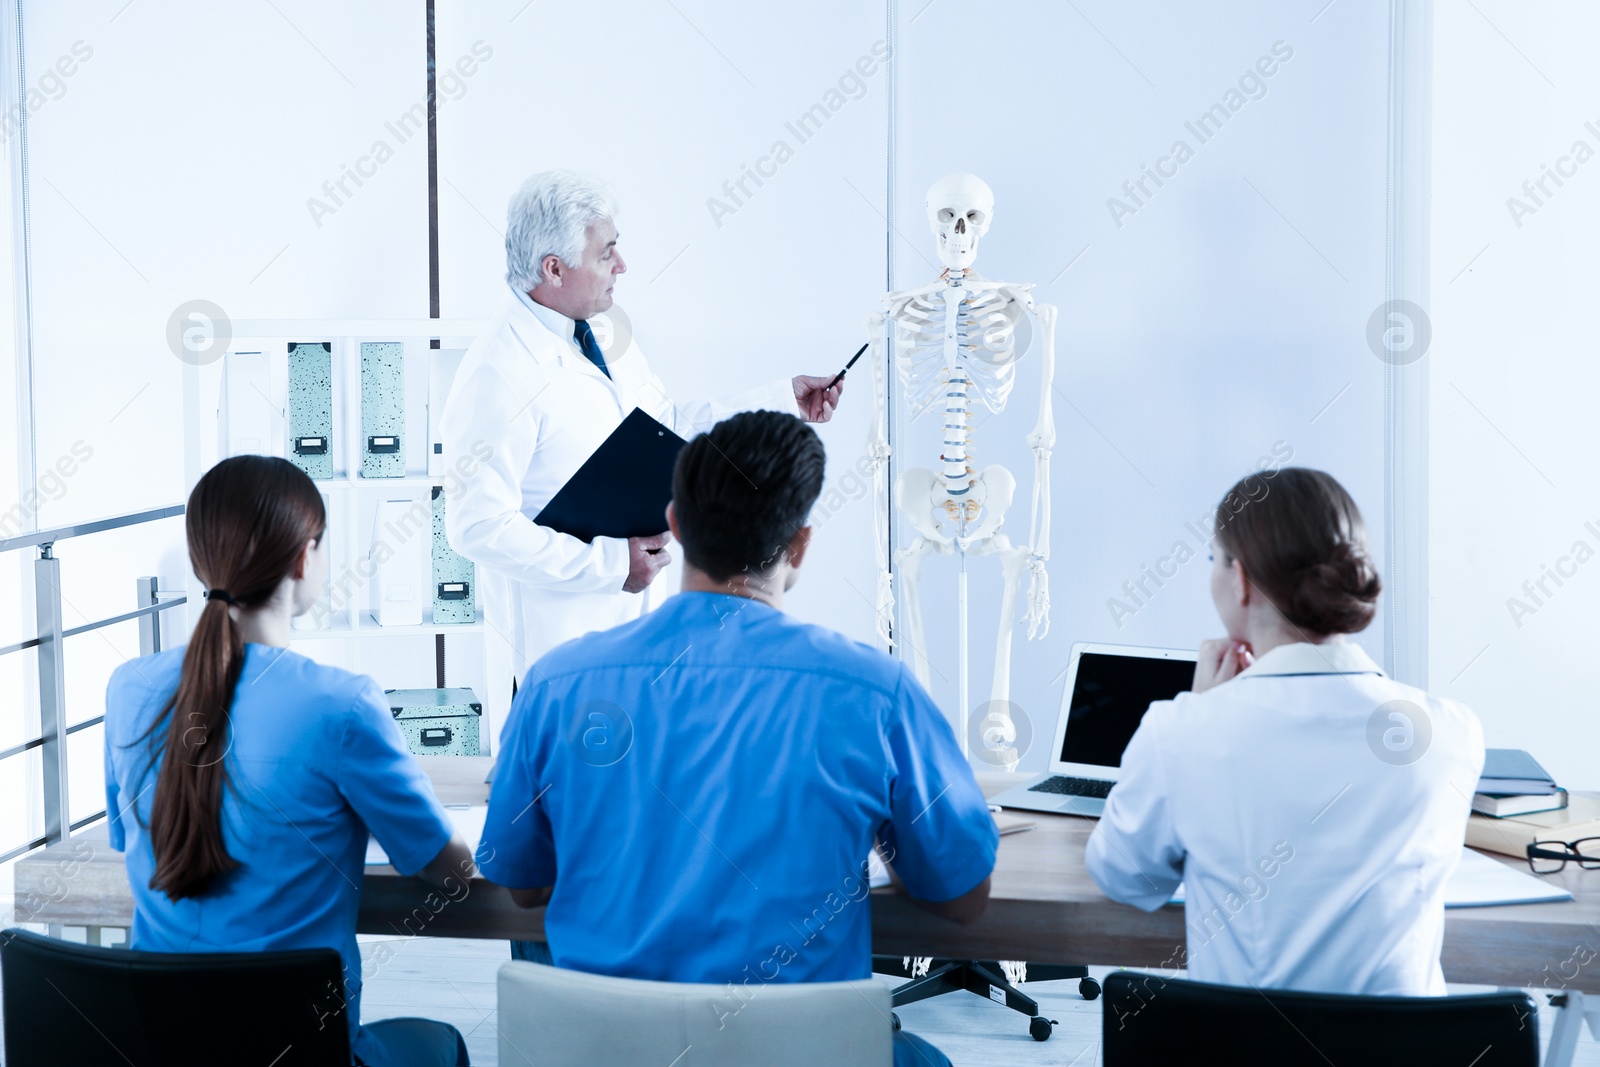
xmin=1061 ymin=653 xmax=1195 ymax=766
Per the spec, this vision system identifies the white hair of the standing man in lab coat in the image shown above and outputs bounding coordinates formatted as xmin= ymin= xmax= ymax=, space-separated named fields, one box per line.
xmin=506 ymin=171 xmax=616 ymax=293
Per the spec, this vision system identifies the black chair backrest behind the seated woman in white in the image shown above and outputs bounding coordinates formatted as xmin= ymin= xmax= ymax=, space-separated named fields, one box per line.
xmin=1101 ymin=971 xmax=1539 ymax=1067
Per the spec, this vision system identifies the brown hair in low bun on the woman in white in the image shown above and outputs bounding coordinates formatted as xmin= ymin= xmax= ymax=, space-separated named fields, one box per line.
xmin=1216 ymin=467 xmax=1384 ymax=635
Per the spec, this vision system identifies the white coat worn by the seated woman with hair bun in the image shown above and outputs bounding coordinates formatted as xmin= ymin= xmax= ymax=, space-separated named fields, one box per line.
xmin=1086 ymin=641 xmax=1483 ymax=997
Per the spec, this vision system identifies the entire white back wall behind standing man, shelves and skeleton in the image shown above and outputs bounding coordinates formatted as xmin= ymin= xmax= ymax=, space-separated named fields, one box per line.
xmin=12 ymin=0 xmax=1408 ymax=809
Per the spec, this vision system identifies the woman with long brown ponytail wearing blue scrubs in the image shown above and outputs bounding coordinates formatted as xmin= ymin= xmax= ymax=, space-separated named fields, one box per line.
xmin=106 ymin=456 xmax=475 ymax=1065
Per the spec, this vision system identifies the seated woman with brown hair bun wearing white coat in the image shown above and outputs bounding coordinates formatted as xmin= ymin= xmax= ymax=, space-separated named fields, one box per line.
xmin=1088 ymin=467 xmax=1483 ymax=997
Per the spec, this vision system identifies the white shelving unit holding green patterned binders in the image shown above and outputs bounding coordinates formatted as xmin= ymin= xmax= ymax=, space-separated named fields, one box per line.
xmin=184 ymin=318 xmax=510 ymax=752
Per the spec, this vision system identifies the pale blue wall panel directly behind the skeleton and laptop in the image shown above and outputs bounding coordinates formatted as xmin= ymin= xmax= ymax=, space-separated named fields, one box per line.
xmin=896 ymin=2 xmax=1387 ymax=769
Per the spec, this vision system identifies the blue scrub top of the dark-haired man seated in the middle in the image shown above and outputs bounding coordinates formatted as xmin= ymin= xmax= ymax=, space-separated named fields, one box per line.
xmin=478 ymin=592 xmax=998 ymax=984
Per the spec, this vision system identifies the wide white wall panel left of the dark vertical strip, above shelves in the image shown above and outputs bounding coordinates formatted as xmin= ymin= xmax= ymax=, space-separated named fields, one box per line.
xmin=10 ymin=0 xmax=430 ymax=817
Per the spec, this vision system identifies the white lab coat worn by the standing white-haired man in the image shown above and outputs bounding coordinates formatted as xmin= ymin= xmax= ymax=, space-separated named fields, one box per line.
xmin=440 ymin=290 xmax=800 ymax=685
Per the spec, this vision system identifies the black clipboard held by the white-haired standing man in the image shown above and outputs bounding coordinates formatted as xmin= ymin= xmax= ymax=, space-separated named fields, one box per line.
xmin=533 ymin=408 xmax=686 ymax=542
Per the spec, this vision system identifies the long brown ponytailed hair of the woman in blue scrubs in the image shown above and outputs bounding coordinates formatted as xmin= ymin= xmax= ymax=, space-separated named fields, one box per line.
xmin=146 ymin=456 xmax=326 ymax=901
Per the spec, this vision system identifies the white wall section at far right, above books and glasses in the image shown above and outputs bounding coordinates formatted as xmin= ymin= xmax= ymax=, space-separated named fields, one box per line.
xmin=1427 ymin=0 xmax=1600 ymax=789
